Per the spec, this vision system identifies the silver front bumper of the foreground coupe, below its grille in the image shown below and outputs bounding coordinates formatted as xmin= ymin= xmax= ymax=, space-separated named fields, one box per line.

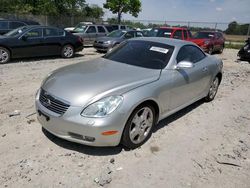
xmin=35 ymin=91 xmax=126 ymax=146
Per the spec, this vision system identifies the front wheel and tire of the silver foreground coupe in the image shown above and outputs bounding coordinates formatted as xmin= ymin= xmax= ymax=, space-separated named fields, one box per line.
xmin=122 ymin=104 xmax=156 ymax=149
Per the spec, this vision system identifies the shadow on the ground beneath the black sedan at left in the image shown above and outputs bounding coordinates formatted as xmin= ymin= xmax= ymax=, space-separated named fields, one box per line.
xmin=8 ymin=54 xmax=85 ymax=64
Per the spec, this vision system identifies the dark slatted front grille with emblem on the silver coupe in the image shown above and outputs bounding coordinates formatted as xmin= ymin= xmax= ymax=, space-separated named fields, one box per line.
xmin=39 ymin=89 xmax=70 ymax=115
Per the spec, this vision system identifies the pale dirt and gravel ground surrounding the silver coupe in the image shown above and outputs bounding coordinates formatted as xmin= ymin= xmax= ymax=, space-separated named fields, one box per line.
xmin=0 ymin=48 xmax=250 ymax=188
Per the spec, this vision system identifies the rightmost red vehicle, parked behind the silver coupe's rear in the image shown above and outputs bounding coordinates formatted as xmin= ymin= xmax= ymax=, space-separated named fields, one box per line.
xmin=190 ymin=31 xmax=225 ymax=54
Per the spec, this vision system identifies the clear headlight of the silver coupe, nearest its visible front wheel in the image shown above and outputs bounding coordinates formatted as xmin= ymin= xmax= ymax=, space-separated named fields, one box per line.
xmin=81 ymin=96 xmax=123 ymax=117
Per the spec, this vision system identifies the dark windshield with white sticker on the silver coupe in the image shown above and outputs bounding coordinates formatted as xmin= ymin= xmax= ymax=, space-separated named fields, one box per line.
xmin=104 ymin=41 xmax=174 ymax=69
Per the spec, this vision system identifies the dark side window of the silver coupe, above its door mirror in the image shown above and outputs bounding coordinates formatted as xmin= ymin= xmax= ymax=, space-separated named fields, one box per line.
xmin=176 ymin=45 xmax=206 ymax=63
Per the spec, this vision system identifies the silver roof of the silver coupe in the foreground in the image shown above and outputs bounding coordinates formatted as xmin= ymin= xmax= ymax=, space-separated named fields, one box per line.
xmin=130 ymin=37 xmax=195 ymax=47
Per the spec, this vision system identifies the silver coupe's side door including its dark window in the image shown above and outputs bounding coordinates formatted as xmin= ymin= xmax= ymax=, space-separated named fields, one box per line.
xmin=169 ymin=45 xmax=211 ymax=110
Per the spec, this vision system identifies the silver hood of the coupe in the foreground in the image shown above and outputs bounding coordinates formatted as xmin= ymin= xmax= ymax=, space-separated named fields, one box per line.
xmin=42 ymin=58 xmax=161 ymax=106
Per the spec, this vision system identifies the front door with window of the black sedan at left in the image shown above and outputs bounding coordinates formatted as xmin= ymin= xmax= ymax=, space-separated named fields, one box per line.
xmin=12 ymin=28 xmax=44 ymax=57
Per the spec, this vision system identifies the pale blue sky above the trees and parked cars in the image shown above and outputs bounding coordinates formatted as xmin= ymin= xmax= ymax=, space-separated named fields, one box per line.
xmin=86 ymin=0 xmax=250 ymax=23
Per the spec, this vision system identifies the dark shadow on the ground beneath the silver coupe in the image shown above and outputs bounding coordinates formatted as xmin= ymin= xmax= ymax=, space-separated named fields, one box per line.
xmin=42 ymin=100 xmax=204 ymax=156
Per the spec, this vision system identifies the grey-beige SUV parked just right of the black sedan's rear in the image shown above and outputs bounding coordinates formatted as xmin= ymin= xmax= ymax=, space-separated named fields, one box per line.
xmin=71 ymin=24 xmax=109 ymax=45
